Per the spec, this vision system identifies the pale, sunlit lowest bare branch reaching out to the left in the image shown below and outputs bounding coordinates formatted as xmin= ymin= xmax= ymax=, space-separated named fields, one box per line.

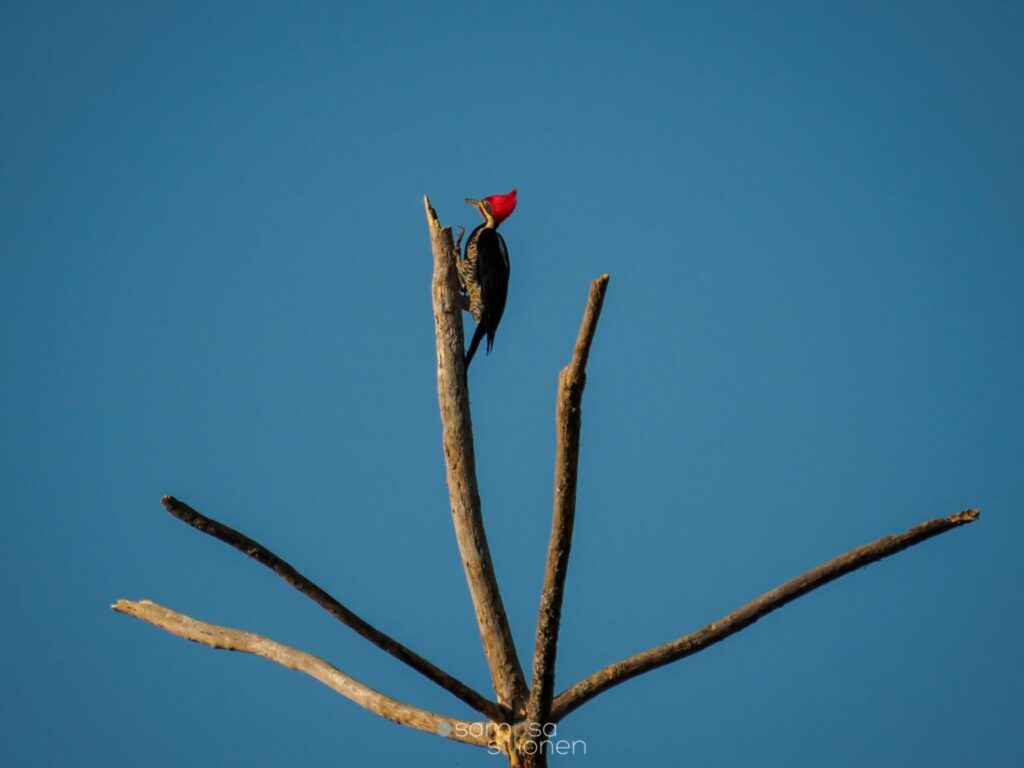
xmin=111 ymin=600 xmax=487 ymax=746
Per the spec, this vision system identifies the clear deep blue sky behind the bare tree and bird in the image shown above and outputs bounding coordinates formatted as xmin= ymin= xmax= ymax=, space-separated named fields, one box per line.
xmin=0 ymin=2 xmax=1024 ymax=767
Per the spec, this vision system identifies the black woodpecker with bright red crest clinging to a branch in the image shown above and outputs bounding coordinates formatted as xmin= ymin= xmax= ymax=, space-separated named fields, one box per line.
xmin=459 ymin=189 xmax=516 ymax=369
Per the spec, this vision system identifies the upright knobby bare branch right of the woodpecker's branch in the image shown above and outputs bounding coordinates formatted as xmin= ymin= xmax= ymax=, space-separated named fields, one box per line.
xmin=526 ymin=274 xmax=608 ymax=724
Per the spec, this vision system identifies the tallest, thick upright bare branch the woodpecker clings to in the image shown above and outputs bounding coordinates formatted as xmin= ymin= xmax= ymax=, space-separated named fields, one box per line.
xmin=423 ymin=197 xmax=526 ymax=711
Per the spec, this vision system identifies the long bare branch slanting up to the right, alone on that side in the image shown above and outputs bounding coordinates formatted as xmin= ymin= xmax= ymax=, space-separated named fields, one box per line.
xmin=551 ymin=509 xmax=981 ymax=721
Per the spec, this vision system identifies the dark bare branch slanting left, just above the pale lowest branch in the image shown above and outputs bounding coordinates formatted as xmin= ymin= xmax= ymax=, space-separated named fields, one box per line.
xmin=161 ymin=496 xmax=508 ymax=722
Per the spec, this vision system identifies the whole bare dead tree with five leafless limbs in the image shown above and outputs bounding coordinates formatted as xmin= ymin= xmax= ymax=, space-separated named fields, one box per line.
xmin=113 ymin=198 xmax=979 ymax=768
